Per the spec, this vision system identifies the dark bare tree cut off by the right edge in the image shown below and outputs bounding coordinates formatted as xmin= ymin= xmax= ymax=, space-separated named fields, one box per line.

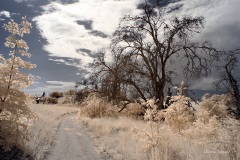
xmin=216 ymin=49 xmax=240 ymax=118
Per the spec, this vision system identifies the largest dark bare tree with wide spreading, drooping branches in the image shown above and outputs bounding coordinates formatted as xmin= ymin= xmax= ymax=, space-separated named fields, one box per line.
xmin=93 ymin=2 xmax=217 ymax=109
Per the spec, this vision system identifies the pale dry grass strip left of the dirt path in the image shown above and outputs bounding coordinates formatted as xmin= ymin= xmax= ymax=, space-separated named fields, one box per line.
xmin=27 ymin=104 xmax=78 ymax=160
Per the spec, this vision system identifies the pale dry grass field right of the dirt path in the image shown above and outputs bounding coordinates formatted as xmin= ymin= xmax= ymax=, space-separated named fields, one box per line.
xmin=80 ymin=117 xmax=240 ymax=160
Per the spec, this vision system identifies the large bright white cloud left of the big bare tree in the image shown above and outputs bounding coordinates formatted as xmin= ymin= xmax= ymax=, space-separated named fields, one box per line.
xmin=34 ymin=0 xmax=142 ymax=67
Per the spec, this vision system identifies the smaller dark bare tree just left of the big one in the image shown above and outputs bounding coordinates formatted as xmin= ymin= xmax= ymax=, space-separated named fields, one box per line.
xmin=91 ymin=51 xmax=128 ymax=100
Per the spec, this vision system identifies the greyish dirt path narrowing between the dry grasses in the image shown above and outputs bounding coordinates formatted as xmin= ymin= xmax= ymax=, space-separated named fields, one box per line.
xmin=46 ymin=114 xmax=101 ymax=160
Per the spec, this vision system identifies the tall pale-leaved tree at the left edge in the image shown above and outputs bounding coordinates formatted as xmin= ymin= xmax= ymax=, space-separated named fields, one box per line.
xmin=0 ymin=17 xmax=36 ymax=149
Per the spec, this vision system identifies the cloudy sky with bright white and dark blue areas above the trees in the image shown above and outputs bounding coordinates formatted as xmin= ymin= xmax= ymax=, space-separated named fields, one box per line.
xmin=0 ymin=0 xmax=240 ymax=95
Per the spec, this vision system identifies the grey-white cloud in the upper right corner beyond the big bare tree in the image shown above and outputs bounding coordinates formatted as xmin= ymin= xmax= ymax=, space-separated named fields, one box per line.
xmin=162 ymin=0 xmax=240 ymax=49
